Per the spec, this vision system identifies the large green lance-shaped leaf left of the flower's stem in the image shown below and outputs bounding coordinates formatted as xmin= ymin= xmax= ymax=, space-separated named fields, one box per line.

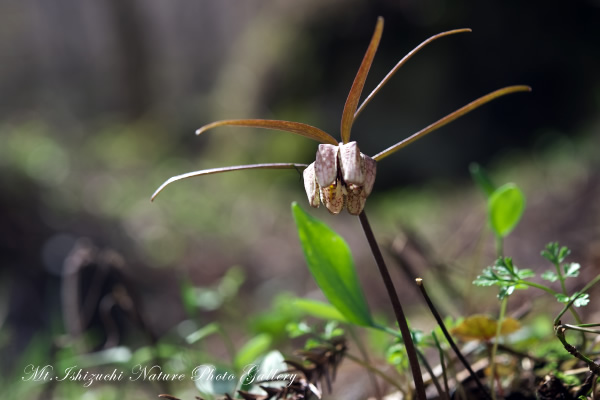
xmin=292 ymin=202 xmax=373 ymax=326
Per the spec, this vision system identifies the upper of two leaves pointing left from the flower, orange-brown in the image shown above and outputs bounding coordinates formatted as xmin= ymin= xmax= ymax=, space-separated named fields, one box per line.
xmin=196 ymin=119 xmax=338 ymax=146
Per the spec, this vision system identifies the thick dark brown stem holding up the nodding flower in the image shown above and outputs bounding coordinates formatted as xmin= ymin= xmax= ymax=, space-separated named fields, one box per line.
xmin=358 ymin=210 xmax=427 ymax=400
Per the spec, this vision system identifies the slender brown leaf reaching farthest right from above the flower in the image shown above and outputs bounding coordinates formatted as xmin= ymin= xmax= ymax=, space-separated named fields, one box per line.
xmin=373 ymin=85 xmax=531 ymax=161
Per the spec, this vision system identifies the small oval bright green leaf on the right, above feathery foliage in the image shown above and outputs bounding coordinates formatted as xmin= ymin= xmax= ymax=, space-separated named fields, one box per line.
xmin=488 ymin=183 xmax=525 ymax=237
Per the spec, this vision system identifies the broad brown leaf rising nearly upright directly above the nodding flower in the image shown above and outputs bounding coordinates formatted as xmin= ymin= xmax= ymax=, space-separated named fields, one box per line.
xmin=340 ymin=17 xmax=383 ymax=143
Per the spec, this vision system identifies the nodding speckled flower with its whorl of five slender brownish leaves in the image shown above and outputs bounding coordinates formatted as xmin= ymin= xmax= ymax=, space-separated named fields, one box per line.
xmin=152 ymin=17 xmax=531 ymax=215
